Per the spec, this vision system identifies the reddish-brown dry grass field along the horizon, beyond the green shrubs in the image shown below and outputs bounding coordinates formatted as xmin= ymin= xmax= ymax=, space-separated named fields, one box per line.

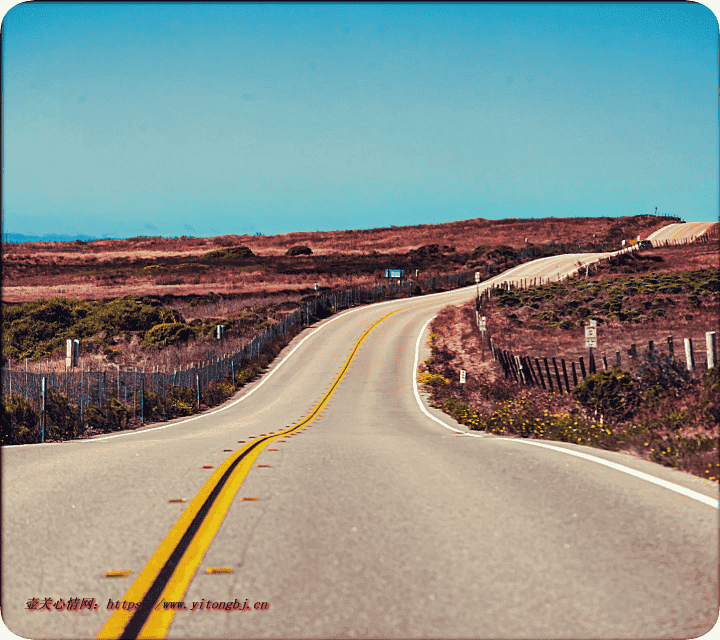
xmin=2 ymin=216 xmax=677 ymax=302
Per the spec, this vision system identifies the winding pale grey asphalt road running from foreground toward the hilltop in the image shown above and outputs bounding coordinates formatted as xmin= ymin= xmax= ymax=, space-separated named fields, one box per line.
xmin=2 ymin=228 xmax=718 ymax=638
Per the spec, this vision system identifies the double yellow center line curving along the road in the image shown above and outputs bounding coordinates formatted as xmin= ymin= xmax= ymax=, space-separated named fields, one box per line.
xmin=98 ymin=309 xmax=399 ymax=638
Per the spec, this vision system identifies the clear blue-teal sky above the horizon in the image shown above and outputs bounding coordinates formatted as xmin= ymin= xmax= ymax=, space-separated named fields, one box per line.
xmin=2 ymin=3 xmax=720 ymax=237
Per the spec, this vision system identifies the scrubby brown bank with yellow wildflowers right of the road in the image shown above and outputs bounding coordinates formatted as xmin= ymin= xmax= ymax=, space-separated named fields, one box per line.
xmin=418 ymin=242 xmax=720 ymax=482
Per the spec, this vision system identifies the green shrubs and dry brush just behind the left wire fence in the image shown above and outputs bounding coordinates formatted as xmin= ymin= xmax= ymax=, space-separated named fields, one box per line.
xmin=2 ymin=294 xmax=301 ymax=371
